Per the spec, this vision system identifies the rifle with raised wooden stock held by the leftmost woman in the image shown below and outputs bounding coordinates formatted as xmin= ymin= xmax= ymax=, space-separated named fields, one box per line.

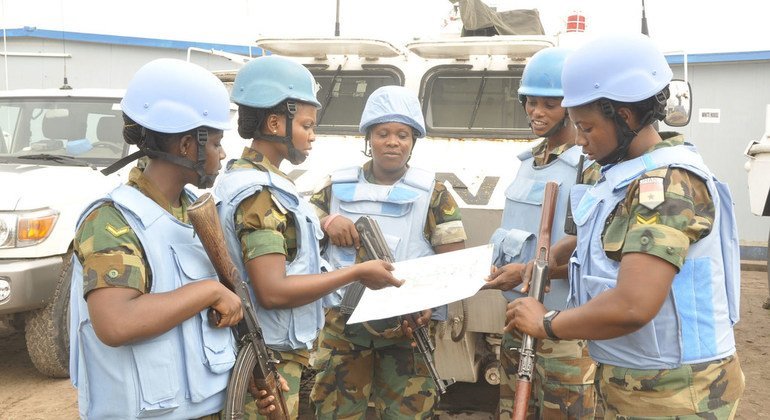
xmin=187 ymin=193 xmax=289 ymax=420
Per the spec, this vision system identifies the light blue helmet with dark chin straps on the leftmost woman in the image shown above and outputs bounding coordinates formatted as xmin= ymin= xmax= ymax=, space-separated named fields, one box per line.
xmin=102 ymin=58 xmax=230 ymax=186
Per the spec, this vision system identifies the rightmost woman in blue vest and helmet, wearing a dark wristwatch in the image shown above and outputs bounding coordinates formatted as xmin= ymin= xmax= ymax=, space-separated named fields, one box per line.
xmin=506 ymin=36 xmax=744 ymax=418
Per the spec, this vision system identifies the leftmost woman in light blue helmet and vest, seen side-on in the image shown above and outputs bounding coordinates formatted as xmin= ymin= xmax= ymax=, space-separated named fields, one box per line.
xmin=70 ymin=59 xmax=242 ymax=419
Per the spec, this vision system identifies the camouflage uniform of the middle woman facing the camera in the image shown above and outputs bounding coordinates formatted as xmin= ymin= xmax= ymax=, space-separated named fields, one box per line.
xmin=310 ymin=161 xmax=465 ymax=419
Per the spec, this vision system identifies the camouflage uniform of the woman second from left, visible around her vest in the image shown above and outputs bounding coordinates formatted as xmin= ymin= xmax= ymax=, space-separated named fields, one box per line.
xmin=229 ymin=147 xmax=310 ymax=418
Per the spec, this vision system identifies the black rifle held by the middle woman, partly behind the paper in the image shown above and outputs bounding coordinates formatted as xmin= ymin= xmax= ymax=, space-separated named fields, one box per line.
xmin=346 ymin=216 xmax=446 ymax=395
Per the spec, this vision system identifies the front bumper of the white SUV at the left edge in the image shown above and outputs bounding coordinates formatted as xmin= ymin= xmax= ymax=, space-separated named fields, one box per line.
xmin=0 ymin=255 xmax=62 ymax=315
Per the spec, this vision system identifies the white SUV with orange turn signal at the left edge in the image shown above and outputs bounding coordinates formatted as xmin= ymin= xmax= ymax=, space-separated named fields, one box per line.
xmin=0 ymin=89 xmax=128 ymax=377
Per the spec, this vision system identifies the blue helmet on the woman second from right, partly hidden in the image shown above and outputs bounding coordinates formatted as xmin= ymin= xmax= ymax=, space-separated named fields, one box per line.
xmin=519 ymin=47 xmax=571 ymax=104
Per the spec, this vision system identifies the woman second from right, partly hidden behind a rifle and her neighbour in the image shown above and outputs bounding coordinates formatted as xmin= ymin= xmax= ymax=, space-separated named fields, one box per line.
xmin=485 ymin=47 xmax=596 ymax=419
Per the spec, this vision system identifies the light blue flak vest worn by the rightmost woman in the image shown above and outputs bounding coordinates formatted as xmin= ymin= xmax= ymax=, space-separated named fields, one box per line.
xmin=570 ymin=144 xmax=740 ymax=369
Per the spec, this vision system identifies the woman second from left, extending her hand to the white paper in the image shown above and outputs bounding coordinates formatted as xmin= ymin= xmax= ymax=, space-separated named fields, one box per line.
xmin=215 ymin=55 xmax=401 ymax=418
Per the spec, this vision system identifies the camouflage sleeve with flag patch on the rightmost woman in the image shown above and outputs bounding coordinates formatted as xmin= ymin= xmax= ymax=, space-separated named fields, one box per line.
xmin=603 ymin=168 xmax=715 ymax=269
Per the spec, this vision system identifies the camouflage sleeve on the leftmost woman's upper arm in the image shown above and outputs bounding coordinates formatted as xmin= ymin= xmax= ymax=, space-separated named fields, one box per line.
xmin=74 ymin=204 xmax=152 ymax=296
